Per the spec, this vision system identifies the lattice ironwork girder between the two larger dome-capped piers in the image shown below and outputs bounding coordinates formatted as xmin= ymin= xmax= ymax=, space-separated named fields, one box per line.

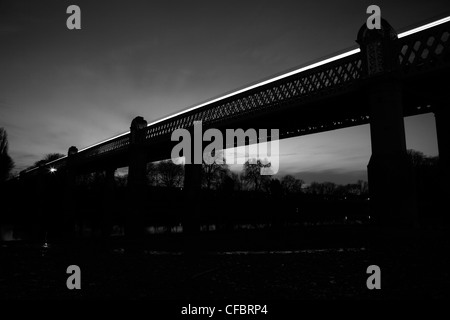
xmin=146 ymin=53 xmax=362 ymax=140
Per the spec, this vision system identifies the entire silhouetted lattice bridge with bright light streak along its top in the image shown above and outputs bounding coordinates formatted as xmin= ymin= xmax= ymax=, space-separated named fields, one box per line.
xmin=20 ymin=17 xmax=450 ymax=228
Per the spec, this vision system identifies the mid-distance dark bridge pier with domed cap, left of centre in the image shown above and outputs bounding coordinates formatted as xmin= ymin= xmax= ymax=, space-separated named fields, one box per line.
xmin=125 ymin=117 xmax=147 ymax=237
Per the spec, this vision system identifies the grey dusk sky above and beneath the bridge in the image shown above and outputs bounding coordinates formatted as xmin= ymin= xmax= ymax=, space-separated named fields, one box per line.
xmin=0 ymin=0 xmax=450 ymax=183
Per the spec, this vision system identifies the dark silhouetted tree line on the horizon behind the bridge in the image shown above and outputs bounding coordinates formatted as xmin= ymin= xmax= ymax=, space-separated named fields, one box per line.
xmin=0 ymin=128 xmax=438 ymax=197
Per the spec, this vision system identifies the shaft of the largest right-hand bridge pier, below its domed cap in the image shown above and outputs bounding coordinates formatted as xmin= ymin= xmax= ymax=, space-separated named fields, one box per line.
xmin=368 ymin=78 xmax=417 ymax=226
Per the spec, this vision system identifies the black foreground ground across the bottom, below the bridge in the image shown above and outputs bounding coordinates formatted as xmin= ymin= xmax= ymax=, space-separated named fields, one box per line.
xmin=0 ymin=226 xmax=450 ymax=302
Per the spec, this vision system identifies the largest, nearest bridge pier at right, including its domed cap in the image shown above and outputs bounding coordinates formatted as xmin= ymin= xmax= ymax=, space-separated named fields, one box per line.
xmin=357 ymin=19 xmax=418 ymax=226
